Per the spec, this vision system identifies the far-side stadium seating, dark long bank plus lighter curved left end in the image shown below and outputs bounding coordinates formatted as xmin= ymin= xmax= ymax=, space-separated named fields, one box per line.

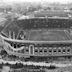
xmin=1 ymin=18 xmax=72 ymax=38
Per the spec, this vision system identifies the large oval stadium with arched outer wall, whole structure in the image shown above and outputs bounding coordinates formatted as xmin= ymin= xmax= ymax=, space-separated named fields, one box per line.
xmin=0 ymin=17 xmax=72 ymax=61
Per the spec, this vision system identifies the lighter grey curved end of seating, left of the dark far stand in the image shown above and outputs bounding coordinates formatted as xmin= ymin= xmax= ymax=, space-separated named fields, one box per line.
xmin=1 ymin=24 xmax=20 ymax=39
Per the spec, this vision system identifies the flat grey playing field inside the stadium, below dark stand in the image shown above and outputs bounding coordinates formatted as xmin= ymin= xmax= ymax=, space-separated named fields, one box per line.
xmin=29 ymin=30 xmax=70 ymax=41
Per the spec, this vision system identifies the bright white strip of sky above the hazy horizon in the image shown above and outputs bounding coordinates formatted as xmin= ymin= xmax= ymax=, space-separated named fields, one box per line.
xmin=0 ymin=0 xmax=72 ymax=3
